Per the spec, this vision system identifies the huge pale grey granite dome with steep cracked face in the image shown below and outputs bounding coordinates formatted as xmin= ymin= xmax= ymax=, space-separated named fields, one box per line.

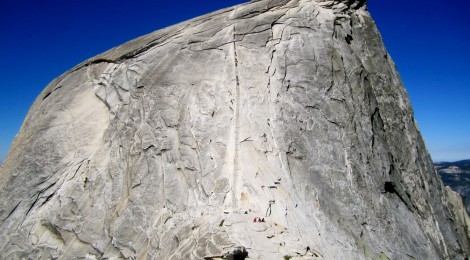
xmin=0 ymin=0 xmax=470 ymax=259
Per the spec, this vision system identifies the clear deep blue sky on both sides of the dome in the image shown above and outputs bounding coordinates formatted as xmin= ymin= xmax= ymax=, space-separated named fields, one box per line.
xmin=0 ymin=0 xmax=470 ymax=161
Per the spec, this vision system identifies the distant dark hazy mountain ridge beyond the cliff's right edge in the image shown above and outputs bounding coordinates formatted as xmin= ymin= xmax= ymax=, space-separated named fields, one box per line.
xmin=434 ymin=160 xmax=470 ymax=213
